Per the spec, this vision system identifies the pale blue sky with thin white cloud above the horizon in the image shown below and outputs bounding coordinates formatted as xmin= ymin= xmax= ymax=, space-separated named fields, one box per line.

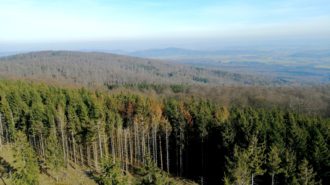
xmin=0 ymin=0 xmax=330 ymax=52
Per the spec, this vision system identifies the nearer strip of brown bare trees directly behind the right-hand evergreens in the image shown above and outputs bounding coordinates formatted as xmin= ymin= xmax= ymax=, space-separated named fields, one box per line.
xmin=107 ymin=83 xmax=330 ymax=117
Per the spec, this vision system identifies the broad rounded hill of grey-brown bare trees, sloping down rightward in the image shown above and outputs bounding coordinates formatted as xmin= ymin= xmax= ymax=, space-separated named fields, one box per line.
xmin=0 ymin=51 xmax=285 ymax=86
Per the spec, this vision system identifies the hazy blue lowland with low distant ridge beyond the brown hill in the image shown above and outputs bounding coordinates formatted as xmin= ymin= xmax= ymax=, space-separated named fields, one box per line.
xmin=113 ymin=47 xmax=330 ymax=85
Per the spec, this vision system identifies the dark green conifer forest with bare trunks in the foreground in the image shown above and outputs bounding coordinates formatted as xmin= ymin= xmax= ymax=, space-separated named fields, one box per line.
xmin=0 ymin=80 xmax=330 ymax=185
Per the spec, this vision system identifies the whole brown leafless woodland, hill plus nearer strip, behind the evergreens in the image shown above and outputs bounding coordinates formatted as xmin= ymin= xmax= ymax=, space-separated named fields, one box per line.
xmin=0 ymin=51 xmax=330 ymax=116
